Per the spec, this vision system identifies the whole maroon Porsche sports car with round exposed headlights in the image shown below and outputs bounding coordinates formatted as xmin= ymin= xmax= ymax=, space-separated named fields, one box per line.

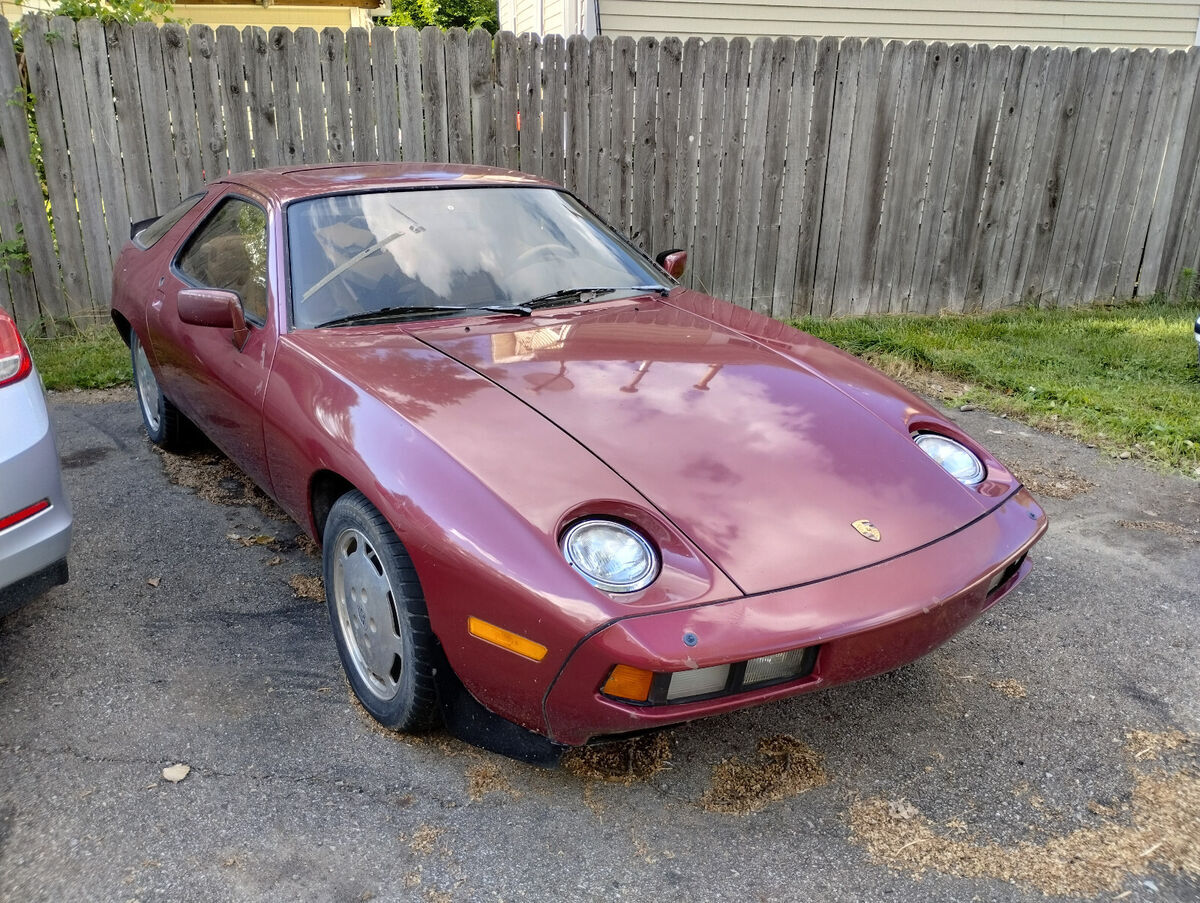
xmin=113 ymin=165 xmax=1046 ymax=760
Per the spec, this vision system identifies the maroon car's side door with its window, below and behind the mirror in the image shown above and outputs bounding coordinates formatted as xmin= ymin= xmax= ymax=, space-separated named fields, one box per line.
xmin=149 ymin=193 xmax=278 ymax=491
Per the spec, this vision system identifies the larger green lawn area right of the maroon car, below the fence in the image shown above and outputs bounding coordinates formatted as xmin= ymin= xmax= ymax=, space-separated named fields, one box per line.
xmin=794 ymin=300 xmax=1200 ymax=476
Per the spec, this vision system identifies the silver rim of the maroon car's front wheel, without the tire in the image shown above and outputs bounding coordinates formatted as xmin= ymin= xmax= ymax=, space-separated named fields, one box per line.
xmin=332 ymin=528 xmax=403 ymax=700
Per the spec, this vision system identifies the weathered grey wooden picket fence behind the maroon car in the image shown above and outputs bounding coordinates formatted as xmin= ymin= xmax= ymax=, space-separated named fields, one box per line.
xmin=0 ymin=17 xmax=1200 ymax=328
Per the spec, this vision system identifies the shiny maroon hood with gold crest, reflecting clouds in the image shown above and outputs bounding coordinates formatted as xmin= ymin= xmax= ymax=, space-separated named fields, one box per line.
xmin=410 ymin=298 xmax=998 ymax=593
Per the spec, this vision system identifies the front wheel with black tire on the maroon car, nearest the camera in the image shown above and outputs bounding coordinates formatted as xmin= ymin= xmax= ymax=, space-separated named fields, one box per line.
xmin=323 ymin=490 xmax=438 ymax=731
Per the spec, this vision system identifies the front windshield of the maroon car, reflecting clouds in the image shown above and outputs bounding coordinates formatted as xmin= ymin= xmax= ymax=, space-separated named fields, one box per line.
xmin=288 ymin=187 xmax=671 ymax=329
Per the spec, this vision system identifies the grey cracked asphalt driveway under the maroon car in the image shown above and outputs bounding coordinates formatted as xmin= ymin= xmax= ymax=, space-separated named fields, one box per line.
xmin=0 ymin=391 xmax=1200 ymax=903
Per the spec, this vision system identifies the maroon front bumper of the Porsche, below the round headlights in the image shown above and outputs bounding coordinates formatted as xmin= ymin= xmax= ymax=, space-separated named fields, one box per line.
xmin=544 ymin=489 xmax=1048 ymax=746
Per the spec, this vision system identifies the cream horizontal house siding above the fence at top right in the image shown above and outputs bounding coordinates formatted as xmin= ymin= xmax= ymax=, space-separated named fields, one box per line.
xmin=592 ymin=0 xmax=1200 ymax=48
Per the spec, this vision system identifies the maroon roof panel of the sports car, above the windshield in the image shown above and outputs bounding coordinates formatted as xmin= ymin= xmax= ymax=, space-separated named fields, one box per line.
xmin=215 ymin=163 xmax=560 ymax=203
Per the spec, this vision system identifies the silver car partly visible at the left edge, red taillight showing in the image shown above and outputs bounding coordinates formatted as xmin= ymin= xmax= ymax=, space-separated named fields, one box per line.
xmin=0 ymin=309 xmax=71 ymax=616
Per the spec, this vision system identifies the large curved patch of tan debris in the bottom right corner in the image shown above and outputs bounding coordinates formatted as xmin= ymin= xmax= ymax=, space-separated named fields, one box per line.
xmin=850 ymin=731 xmax=1200 ymax=897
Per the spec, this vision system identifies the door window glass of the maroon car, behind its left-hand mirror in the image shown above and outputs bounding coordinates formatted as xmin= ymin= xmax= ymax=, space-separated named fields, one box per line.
xmin=179 ymin=198 xmax=266 ymax=325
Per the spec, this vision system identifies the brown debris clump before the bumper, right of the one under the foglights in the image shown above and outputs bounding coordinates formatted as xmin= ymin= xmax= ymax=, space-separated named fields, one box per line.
xmin=700 ymin=734 xmax=829 ymax=815
